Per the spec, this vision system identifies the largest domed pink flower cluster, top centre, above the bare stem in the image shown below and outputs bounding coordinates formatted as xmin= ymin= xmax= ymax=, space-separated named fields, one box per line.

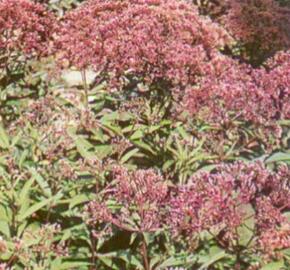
xmin=56 ymin=0 xmax=228 ymax=88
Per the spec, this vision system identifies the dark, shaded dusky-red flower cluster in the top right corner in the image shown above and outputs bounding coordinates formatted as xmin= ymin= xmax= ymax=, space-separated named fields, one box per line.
xmin=193 ymin=0 xmax=290 ymax=64
